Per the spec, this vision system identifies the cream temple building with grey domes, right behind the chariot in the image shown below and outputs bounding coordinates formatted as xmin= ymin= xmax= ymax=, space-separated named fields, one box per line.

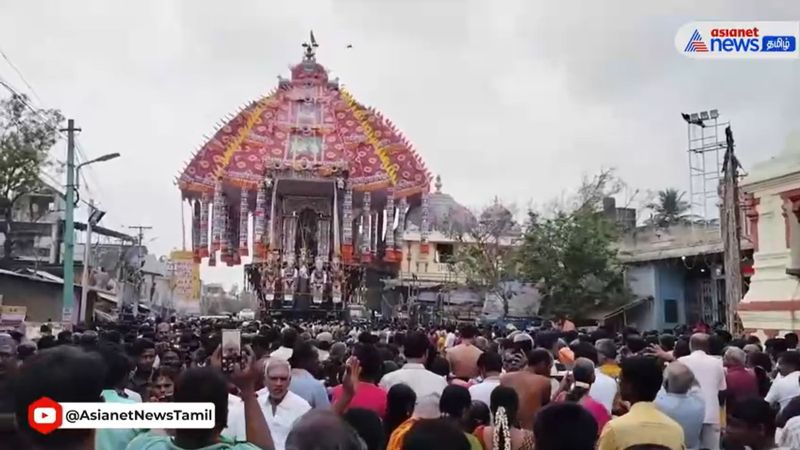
xmin=381 ymin=176 xmax=539 ymax=320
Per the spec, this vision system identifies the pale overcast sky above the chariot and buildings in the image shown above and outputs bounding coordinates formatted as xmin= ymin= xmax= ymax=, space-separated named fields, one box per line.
xmin=0 ymin=0 xmax=800 ymax=285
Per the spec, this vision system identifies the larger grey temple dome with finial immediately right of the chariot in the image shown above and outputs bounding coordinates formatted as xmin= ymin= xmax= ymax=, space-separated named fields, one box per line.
xmin=406 ymin=176 xmax=478 ymax=234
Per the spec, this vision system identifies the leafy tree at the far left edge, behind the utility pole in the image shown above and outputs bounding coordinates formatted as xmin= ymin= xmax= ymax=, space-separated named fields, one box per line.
xmin=0 ymin=94 xmax=63 ymax=259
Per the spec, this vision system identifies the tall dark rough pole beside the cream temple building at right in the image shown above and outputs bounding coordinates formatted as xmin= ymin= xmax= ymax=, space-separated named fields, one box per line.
xmin=720 ymin=126 xmax=742 ymax=335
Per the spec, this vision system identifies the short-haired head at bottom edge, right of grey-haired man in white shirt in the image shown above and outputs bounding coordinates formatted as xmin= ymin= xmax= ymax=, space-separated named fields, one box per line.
xmin=286 ymin=409 xmax=364 ymax=450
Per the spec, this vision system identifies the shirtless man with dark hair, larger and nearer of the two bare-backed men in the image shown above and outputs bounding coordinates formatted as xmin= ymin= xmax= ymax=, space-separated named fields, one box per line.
xmin=500 ymin=348 xmax=553 ymax=430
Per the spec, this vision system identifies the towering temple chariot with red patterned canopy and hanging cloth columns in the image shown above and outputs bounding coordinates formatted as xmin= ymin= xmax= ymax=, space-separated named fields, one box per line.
xmin=178 ymin=34 xmax=431 ymax=315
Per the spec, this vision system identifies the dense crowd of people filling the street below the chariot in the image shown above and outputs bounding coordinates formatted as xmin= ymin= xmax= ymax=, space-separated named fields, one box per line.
xmin=0 ymin=318 xmax=800 ymax=450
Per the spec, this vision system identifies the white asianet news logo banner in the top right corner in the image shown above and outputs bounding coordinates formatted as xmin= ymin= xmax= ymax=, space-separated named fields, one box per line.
xmin=675 ymin=22 xmax=800 ymax=59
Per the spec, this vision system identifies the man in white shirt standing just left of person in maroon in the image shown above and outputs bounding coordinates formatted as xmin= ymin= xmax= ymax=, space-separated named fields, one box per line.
xmin=678 ymin=333 xmax=727 ymax=450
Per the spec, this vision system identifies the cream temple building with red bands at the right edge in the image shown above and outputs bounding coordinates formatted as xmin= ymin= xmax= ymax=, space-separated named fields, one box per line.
xmin=739 ymin=132 xmax=800 ymax=336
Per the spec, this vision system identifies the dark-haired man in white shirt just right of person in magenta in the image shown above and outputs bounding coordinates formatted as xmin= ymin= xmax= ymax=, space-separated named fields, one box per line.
xmin=380 ymin=331 xmax=447 ymax=419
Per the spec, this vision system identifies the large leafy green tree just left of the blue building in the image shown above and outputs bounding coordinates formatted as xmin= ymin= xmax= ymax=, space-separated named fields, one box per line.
xmin=517 ymin=170 xmax=630 ymax=318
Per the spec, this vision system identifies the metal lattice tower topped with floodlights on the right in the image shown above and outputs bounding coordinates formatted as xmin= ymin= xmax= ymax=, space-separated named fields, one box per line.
xmin=681 ymin=109 xmax=730 ymax=225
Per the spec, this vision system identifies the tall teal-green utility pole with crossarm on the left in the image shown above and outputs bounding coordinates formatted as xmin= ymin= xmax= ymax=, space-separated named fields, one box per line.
xmin=61 ymin=119 xmax=81 ymax=324
